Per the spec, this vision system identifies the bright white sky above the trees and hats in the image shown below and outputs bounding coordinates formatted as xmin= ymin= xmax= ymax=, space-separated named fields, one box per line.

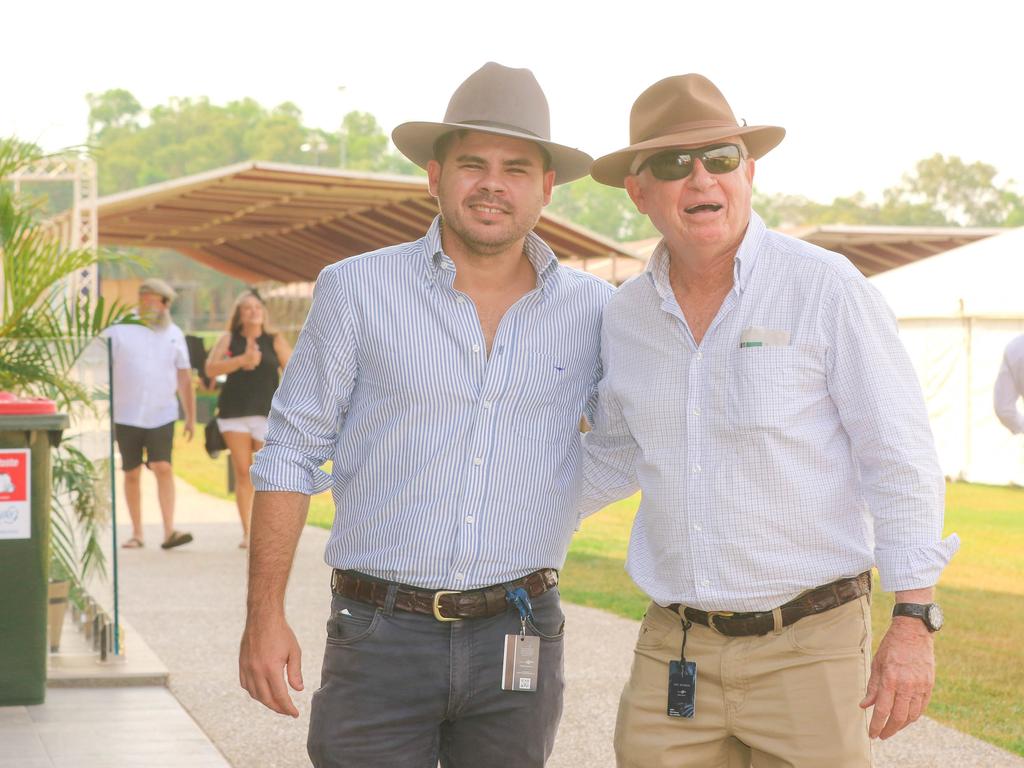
xmin=8 ymin=0 xmax=1024 ymax=202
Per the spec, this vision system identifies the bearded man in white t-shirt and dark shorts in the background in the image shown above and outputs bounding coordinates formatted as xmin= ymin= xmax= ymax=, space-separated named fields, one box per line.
xmin=103 ymin=278 xmax=196 ymax=549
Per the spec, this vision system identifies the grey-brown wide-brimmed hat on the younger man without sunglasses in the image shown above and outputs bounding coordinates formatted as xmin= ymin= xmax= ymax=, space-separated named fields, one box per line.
xmin=391 ymin=61 xmax=594 ymax=184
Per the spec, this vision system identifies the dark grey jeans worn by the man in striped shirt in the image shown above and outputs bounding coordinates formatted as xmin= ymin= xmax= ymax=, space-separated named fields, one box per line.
xmin=307 ymin=587 xmax=565 ymax=768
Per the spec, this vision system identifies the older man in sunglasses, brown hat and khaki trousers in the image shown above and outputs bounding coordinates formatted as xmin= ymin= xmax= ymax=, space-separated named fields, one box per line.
xmin=584 ymin=75 xmax=957 ymax=768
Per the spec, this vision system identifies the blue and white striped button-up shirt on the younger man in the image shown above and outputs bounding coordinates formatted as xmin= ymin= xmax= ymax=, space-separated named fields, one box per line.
xmin=252 ymin=217 xmax=612 ymax=590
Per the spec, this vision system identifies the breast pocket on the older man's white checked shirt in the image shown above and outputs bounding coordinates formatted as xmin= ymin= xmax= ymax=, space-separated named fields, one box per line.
xmin=725 ymin=345 xmax=827 ymax=431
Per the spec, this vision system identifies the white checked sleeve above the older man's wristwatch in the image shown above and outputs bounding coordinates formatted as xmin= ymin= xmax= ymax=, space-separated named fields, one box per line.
xmin=825 ymin=280 xmax=959 ymax=592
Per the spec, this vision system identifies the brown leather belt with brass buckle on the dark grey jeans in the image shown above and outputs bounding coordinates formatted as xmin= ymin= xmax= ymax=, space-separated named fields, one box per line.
xmin=331 ymin=568 xmax=558 ymax=622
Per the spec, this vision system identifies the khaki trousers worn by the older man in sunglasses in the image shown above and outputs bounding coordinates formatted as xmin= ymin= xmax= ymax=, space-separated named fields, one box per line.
xmin=615 ymin=597 xmax=871 ymax=768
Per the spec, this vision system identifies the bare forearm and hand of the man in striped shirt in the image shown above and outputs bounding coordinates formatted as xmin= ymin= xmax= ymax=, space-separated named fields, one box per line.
xmin=239 ymin=492 xmax=309 ymax=718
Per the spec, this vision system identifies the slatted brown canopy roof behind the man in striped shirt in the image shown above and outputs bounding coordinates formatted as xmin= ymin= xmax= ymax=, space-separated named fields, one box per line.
xmin=97 ymin=162 xmax=636 ymax=283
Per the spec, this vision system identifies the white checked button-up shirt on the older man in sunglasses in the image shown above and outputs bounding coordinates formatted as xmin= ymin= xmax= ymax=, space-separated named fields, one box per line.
xmin=582 ymin=214 xmax=958 ymax=611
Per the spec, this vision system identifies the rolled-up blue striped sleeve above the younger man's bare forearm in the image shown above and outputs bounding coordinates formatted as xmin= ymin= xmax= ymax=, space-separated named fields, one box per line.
xmin=251 ymin=264 xmax=358 ymax=496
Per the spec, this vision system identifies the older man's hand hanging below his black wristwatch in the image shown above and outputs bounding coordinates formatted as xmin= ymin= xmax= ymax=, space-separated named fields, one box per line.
xmin=860 ymin=616 xmax=935 ymax=738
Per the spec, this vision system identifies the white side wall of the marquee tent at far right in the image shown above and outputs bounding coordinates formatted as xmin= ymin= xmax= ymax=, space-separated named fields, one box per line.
xmin=899 ymin=316 xmax=1024 ymax=485
